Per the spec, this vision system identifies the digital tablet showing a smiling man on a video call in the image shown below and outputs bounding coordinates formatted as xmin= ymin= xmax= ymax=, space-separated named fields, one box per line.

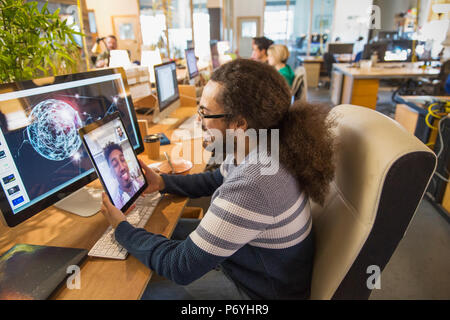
xmin=78 ymin=112 xmax=148 ymax=212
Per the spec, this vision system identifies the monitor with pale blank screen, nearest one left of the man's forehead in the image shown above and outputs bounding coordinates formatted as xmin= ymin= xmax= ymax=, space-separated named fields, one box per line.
xmin=155 ymin=61 xmax=180 ymax=111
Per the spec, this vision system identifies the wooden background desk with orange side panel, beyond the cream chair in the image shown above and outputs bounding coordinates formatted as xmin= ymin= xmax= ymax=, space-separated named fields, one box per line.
xmin=331 ymin=63 xmax=439 ymax=110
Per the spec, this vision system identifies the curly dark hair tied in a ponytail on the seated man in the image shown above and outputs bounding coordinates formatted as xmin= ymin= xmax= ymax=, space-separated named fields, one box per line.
xmin=211 ymin=59 xmax=335 ymax=204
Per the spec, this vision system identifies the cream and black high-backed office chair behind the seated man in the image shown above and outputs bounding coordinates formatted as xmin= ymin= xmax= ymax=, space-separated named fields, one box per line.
xmin=311 ymin=105 xmax=436 ymax=300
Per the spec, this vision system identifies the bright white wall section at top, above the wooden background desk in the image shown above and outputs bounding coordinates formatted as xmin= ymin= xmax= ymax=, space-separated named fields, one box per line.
xmin=331 ymin=0 xmax=372 ymax=42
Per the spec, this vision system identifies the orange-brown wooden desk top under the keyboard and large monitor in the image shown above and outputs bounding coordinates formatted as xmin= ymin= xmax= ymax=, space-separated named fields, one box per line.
xmin=0 ymin=107 xmax=205 ymax=300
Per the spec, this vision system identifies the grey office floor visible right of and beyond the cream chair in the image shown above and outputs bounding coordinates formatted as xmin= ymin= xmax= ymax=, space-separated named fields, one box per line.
xmin=308 ymin=87 xmax=450 ymax=300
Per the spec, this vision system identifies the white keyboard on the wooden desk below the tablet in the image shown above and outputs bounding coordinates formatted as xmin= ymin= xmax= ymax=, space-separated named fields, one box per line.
xmin=88 ymin=192 xmax=162 ymax=260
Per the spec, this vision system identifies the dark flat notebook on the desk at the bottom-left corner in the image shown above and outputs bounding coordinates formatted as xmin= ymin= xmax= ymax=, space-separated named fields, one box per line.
xmin=0 ymin=244 xmax=87 ymax=300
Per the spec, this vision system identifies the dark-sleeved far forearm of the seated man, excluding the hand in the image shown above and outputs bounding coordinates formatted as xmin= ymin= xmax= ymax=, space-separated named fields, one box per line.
xmin=161 ymin=169 xmax=223 ymax=198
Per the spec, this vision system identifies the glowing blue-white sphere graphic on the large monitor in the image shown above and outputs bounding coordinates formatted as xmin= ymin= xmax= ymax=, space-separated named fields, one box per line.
xmin=27 ymin=99 xmax=83 ymax=161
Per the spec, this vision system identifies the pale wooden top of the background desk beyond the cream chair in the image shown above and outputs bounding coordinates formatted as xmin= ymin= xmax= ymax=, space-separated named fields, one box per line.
xmin=333 ymin=63 xmax=440 ymax=79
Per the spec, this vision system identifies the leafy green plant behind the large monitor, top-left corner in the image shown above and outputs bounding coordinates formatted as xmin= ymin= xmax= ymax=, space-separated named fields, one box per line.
xmin=0 ymin=0 xmax=82 ymax=83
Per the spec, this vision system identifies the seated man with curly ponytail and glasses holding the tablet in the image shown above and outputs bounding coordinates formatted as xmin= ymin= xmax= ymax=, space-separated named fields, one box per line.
xmin=102 ymin=59 xmax=334 ymax=299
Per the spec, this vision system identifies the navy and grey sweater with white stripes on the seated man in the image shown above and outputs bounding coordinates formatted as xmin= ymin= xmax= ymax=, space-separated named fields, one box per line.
xmin=115 ymin=151 xmax=314 ymax=299
